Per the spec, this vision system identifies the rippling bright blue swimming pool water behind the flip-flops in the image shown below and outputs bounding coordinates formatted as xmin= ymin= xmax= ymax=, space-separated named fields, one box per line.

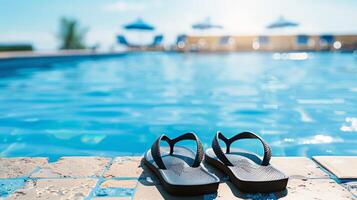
xmin=0 ymin=53 xmax=357 ymax=159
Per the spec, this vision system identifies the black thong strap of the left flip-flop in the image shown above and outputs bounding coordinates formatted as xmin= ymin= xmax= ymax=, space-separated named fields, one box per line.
xmin=151 ymin=133 xmax=203 ymax=169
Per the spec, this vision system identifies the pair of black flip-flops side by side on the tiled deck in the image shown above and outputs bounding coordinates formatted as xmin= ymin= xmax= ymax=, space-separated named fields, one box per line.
xmin=143 ymin=132 xmax=288 ymax=195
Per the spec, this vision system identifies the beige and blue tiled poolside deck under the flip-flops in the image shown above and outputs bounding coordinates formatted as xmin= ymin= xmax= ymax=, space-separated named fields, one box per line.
xmin=0 ymin=157 xmax=357 ymax=200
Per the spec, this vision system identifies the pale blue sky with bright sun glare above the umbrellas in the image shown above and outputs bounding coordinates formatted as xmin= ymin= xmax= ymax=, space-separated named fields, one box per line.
xmin=0 ymin=0 xmax=357 ymax=50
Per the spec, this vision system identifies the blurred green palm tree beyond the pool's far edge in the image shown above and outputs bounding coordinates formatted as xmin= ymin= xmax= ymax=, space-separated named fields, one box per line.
xmin=58 ymin=17 xmax=88 ymax=49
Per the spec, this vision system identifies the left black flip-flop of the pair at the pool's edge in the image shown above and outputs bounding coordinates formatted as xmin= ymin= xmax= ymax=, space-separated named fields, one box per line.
xmin=143 ymin=133 xmax=219 ymax=196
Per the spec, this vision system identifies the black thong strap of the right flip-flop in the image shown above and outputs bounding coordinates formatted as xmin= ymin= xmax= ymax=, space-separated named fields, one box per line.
xmin=212 ymin=132 xmax=271 ymax=166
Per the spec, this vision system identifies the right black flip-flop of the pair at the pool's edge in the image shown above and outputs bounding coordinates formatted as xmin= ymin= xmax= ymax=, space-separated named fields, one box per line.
xmin=205 ymin=132 xmax=288 ymax=193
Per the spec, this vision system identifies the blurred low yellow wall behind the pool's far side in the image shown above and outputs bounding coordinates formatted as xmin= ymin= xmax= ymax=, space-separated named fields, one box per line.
xmin=181 ymin=35 xmax=357 ymax=51
